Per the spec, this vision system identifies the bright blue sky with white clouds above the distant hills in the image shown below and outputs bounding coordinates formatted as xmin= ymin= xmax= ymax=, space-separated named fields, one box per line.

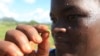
xmin=0 ymin=0 xmax=51 ymax=23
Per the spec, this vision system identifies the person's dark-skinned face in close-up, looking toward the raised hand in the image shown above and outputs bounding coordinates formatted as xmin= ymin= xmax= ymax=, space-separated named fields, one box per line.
xmin=50 ymin=0 xmax=100 ymax=56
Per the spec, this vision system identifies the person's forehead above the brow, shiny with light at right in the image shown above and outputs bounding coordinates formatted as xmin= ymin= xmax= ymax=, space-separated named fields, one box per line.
xmin=51 ymin=0 xmax=100 ymax=13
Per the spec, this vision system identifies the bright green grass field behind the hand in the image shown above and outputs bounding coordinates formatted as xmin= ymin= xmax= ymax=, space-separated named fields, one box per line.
xmin=0 ymin=23 xmax=54 ymax=48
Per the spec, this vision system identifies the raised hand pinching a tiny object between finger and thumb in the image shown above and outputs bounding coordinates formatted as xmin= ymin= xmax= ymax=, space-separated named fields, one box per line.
xmin=0 ymin=25 xmax=49 ymax=56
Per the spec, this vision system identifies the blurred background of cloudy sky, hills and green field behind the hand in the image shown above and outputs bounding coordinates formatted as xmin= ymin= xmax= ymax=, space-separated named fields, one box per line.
xmin=0 ymin=0 xmax=54 ymax=48
